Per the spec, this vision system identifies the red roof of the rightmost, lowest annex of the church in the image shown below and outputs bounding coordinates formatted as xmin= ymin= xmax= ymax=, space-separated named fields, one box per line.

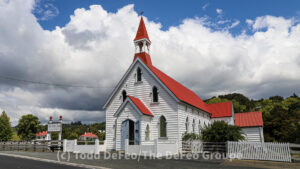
xmin=234 ymin=111 xmax=264 ymax=127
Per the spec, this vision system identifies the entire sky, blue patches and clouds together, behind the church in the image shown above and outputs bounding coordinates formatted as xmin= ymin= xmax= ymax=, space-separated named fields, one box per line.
xmin=0 ymin=0 xmax=300 ymax=125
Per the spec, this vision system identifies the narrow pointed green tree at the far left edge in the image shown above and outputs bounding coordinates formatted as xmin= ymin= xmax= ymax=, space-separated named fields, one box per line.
xmin=0 ymin=111 xmax=13 ymax=141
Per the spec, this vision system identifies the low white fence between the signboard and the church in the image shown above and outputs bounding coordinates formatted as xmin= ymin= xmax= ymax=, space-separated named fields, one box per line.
xmin=63 ymin=139 xmax=106 ymax=154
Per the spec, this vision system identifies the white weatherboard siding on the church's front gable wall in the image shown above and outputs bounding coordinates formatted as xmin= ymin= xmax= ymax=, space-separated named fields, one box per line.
xmin=106 ymin=61 xmax=178 ymax=150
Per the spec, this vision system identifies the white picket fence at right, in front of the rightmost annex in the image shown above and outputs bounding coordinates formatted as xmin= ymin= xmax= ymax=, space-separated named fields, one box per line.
xmin=228 ymin=142 xmax=291 ymax=162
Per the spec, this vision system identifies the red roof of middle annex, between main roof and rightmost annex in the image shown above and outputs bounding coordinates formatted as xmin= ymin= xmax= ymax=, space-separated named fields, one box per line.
xmin=207 ymin=102 xmax=233 ymax=118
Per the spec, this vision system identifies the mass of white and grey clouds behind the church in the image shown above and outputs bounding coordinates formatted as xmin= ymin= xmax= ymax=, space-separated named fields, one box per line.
xmin=0 ymin=0 xmax=300 ymax=124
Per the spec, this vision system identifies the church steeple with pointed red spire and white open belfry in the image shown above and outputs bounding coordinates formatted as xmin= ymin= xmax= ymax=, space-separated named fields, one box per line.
xmin=134 ymin=16 xmax=151 ymax=54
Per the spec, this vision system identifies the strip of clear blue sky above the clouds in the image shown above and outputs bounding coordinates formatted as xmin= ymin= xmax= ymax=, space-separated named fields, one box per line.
xmin=35 ymin=0 xmax=300 ymax=34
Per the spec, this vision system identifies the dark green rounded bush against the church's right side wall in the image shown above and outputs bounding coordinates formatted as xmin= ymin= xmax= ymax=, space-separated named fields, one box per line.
xmin=201 ymin=121 xmax=244 ymax=142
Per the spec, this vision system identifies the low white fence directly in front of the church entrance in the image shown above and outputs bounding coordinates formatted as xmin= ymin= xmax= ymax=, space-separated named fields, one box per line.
xmin=125 ymin=139 xmax=178 ymax=157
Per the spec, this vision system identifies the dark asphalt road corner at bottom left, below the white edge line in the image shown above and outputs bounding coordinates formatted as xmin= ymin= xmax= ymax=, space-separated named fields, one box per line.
xmin=0 ymin=155 xmax=82 ymax=169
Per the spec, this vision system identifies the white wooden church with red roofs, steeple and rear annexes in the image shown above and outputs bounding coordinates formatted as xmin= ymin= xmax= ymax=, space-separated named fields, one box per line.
xmin=104 ymin=17 xmax=263 ymax=151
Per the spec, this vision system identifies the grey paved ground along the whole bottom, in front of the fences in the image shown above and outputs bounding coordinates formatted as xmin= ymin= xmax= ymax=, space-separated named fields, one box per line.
xmin=0 ymin=152 xmax=300 ymax=169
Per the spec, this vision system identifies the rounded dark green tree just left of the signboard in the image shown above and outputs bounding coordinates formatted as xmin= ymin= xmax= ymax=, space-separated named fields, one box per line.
xmin=17 ymin=114 xmax=40 ymax=140
